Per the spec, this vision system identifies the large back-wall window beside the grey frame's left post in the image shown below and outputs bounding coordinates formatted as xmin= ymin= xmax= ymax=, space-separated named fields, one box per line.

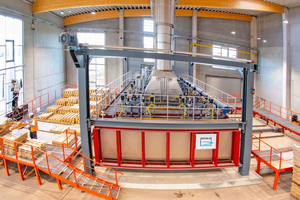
xmin=77 ymin=33 xmax=105 ymax=87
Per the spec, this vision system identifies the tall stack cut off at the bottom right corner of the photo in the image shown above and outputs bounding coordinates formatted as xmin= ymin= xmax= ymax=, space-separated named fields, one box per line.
xmin=291 ymin=144 xmax=300 ymax=200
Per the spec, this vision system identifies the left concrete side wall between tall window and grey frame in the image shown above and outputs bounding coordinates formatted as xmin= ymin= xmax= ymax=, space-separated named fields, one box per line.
xmin=0 ymin=0 xmax=66 ymax=102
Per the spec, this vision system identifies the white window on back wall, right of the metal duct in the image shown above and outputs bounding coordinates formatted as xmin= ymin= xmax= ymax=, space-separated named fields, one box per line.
xmin=212 ymin=45 xmax=237 ymax=70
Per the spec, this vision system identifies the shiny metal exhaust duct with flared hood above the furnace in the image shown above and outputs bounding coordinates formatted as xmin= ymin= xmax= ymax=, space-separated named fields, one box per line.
xmin=145 ymin=0 xmax=182 ymax=95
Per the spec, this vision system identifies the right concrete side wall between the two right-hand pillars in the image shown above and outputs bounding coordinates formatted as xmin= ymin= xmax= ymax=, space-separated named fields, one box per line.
xmin=256 ymin=13 xmax=283 ymax=105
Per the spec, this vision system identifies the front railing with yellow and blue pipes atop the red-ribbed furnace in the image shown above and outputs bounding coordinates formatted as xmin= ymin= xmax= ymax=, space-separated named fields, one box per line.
xmin=97 ymin=94 xmax=235 ymax=120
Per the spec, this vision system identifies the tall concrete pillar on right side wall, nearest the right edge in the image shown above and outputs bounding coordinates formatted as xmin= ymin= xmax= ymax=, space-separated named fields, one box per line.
xmin=282 ymin=8 xmax=291 ymax=109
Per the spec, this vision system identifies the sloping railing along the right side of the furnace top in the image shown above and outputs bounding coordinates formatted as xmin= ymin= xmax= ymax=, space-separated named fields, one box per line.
xmin=187 ymin=75 xmax=236 ymax=105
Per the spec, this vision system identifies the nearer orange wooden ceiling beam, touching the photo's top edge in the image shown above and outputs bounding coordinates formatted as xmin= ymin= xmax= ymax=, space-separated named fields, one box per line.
xmin=32 ymin=0 xmax=284 ymax=14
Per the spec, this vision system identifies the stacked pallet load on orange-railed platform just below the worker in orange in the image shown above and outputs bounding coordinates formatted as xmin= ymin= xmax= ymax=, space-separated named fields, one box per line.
xmin=19 ymin=139 xmax=47 ymax=160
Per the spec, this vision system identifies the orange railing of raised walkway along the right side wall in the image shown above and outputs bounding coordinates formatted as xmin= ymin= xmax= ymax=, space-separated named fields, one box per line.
xmin=254 ymin=98 xmax=300 ymax=122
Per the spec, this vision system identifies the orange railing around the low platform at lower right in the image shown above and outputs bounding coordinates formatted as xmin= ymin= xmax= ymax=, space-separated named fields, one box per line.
xmin=252 ymin=133 xmax=293 ymax=169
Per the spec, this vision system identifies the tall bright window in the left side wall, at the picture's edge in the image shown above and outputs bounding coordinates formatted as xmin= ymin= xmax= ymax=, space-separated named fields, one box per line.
xmin=0 ymin=15 xmax=24 ymax=114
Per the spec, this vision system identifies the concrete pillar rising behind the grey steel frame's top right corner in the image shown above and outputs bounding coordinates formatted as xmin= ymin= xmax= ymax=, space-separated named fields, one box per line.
xmin=250 ymin=17 xmax=258 ymax=97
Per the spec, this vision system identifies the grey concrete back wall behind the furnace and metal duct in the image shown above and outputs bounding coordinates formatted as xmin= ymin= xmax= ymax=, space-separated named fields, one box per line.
xmin=66 ymin=17 xmax=250 ymax=94
